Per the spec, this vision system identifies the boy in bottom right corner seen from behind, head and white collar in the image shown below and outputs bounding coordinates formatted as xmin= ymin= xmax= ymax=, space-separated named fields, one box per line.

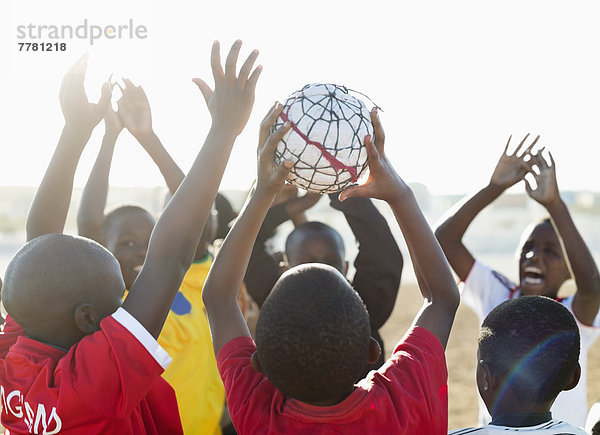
xmin=450 ymin=296 xmax=585 ymax=435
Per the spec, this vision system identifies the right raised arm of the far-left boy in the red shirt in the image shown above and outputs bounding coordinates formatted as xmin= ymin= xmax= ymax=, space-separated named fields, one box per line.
xmin=123 ymin=40 xmax=262 ymax=338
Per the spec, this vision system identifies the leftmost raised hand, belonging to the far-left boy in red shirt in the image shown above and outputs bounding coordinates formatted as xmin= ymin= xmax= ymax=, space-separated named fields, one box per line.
xmin=58 ymin=53 xmax=111 ymax=134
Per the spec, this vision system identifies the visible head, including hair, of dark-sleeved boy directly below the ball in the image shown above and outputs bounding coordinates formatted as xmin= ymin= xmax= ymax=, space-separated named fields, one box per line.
xmin=285 ymin=222 xmax=347 ymax=274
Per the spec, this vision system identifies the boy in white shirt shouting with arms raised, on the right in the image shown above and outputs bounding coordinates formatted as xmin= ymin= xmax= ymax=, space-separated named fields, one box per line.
xmin=435 ymin=135 xmax=600 ymax=426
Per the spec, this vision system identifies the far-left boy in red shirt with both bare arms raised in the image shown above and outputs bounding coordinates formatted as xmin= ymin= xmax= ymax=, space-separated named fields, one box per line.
xmin=0 ymin=41 xmax=261 ymax=434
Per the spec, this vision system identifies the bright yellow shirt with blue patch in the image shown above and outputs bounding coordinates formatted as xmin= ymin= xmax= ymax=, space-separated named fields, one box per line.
xmin=126 ymin=255 xmax=225 ymax=435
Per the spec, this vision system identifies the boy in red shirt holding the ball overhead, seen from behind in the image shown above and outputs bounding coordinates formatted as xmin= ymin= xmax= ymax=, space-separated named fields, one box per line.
xmin=203 ymin=104 xmax=459 ymax=434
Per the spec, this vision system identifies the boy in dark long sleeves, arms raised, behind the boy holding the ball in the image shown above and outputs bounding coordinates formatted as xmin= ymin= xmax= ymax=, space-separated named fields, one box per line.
xmin=244 ymin=175 xmax=403 ymax=375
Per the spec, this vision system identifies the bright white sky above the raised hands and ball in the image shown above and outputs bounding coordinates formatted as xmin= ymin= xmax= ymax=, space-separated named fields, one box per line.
xmin=0 ymin=0 xmax=600 ymax=193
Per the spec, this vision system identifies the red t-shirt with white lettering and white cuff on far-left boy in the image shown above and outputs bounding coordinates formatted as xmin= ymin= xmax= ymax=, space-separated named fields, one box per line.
xmin=0 ymin=308 xmax=182 ymax=434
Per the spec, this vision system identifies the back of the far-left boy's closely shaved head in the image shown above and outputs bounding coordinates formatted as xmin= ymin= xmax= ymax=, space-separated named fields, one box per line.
xmin=2 ymin=234 xmax=125 ymax=344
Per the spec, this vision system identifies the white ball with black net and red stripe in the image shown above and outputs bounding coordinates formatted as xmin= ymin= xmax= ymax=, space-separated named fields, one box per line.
xmin=272 ymin=83 xmax=373 ymax=193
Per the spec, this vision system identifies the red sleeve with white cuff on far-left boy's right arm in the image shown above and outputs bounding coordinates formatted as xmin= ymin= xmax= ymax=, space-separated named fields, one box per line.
xmin=57 ymin=308 xmax=171 ymax=418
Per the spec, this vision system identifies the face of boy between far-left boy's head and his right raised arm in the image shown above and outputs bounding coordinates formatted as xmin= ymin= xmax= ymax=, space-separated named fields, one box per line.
xmin=105 ymin=211 xmax=154 ymax=289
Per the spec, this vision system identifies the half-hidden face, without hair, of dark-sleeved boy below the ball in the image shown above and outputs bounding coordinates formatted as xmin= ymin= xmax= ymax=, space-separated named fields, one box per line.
xmin=286 ymin=232 xmax=347 ymax=276
